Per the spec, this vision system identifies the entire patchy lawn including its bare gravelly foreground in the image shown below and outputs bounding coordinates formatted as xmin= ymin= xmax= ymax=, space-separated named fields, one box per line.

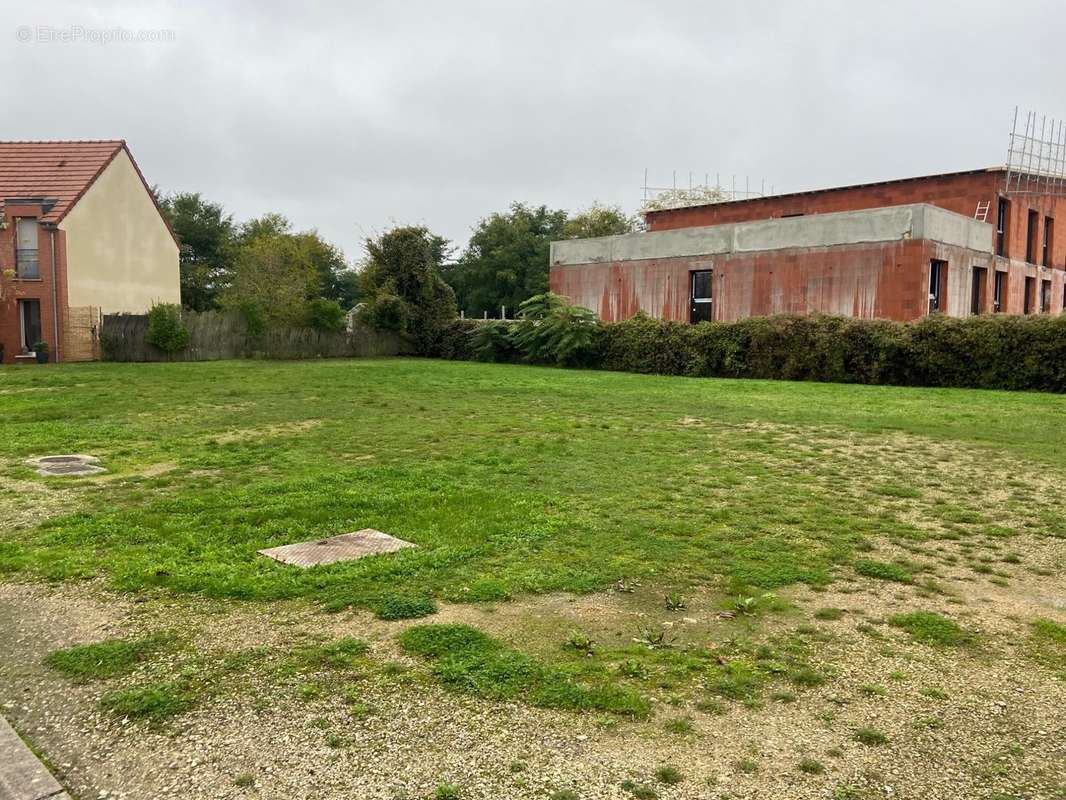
xmin=0 ymin=359 xmax=1066 ymax=798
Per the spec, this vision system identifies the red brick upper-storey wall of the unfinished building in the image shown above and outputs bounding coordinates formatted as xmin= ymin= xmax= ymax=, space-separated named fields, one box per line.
xmin=647 ymin=171 xmax=1066 ymax=269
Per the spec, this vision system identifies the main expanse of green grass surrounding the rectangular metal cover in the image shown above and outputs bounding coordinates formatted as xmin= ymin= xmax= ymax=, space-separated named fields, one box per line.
xmin=0 ymin=359 xmax=1066 ymax=609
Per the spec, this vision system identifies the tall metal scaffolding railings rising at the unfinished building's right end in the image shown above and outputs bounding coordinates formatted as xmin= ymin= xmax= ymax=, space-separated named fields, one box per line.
xmin=1003 ymin=107 xmax=1066 ymax=197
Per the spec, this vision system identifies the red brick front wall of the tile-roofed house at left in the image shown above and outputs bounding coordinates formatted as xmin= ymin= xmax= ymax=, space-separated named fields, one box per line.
xmin=0 ymin=205 xmax=67 ymax=364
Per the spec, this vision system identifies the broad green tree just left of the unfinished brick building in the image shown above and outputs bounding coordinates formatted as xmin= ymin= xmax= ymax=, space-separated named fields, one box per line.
xmin=446 ymin=203 xmax=566 ymax=316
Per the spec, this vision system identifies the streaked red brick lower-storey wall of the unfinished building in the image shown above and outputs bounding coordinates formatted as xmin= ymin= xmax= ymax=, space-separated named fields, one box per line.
xmin=551 ymin=240 xmax=1066 ymax=321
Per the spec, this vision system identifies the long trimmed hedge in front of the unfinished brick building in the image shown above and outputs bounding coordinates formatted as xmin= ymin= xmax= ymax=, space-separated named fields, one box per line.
xmin=427 ymin=315 xmax=1066 ymax=393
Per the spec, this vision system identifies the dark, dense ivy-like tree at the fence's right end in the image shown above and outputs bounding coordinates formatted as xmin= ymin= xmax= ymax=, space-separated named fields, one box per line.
xmin=360 ymin=225 xmax=458 ymax=353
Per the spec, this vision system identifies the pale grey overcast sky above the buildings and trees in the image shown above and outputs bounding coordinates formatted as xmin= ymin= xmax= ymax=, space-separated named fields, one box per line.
xmin=0 ymin=0 xmax=1066 ymax=258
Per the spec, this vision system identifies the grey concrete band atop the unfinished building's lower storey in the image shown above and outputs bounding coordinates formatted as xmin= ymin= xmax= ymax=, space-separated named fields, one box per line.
xmin=551 ymin=204 xmax=992 ymax=267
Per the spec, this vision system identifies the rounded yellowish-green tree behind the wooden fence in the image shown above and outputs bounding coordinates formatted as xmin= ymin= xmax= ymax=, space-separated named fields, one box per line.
xmin=220 ymin=234 xmax=320 ymax=333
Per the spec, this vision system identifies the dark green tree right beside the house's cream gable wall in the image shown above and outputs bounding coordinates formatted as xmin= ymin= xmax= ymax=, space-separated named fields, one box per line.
xmin=157 ymin=192 xmax=236 ymax=311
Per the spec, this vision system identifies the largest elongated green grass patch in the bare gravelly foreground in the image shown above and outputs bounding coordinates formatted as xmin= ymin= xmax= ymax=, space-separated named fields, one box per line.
xmin=399 ymin=624 xmax=649 ymax=718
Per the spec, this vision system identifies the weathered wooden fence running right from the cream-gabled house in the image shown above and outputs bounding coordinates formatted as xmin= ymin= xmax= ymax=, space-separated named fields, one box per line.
xmin=100 ymin=311 xmax=407 ymax=362
